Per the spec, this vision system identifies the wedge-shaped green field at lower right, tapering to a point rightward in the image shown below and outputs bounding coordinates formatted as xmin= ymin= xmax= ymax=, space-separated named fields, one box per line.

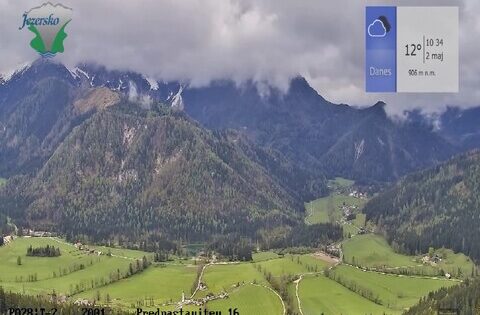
xmin=333 ymin=266 xmax=459 ymax=311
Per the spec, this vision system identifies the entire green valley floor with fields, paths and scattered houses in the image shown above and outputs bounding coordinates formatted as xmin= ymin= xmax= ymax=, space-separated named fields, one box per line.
xmin=0 ymin=180 xmax=475 ymax=315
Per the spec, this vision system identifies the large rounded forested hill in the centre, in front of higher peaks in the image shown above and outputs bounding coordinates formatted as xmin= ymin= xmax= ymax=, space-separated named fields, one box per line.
xmin=0 ymin=103 xmax=330 ymax=246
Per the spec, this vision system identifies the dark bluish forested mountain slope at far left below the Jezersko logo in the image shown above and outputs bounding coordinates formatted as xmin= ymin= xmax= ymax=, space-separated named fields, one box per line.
xmin=0 ymin=60 xmax=119 ymax=177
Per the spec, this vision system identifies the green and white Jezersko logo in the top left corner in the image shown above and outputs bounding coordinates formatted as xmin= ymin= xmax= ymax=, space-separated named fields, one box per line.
xmin=18 ymin=2 xmax=72 ymax=58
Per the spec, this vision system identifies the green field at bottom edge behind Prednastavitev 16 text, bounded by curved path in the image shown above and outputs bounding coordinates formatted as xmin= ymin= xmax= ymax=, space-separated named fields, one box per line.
xmin=207 ymin=284 xmax=283 ymax=315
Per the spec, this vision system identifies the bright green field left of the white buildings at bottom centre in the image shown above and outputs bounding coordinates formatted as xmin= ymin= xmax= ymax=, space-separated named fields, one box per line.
xmin=75 ymin=265 xmax=196 ymax=308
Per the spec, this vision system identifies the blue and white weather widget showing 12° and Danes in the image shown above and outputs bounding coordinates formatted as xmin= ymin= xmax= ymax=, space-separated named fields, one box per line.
xmin=365 ymin=6 xmax=459 ymax=93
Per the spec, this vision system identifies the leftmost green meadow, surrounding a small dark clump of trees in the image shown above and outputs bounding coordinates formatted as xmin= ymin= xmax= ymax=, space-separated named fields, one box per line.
xmin=0 ymin=238 xmax=150 ymax=295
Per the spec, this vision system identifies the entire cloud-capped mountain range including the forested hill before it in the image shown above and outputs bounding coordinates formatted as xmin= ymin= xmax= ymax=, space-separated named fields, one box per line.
xmin=0 ymin=60 xmax=478 ymax=243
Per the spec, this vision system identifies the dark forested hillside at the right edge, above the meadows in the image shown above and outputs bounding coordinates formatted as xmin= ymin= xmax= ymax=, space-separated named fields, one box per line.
xmin=364 ymin=151 xmax=480 ymax=260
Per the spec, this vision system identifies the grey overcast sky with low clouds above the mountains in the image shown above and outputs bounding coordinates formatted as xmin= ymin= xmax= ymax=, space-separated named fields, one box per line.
xmin=0 ymin=0 xmax=480 ymax=113
